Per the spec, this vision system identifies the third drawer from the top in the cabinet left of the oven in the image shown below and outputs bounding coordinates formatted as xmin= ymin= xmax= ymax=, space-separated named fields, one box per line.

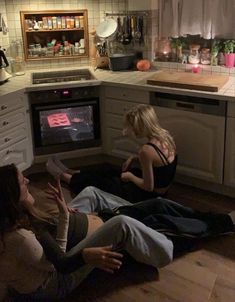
xmin=0 ymin=125 xmax=27 ymax=150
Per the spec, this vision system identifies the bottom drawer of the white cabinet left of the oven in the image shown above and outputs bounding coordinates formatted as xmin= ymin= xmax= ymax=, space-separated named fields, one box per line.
xmin=0 ymin=139 xmax=31 ymax=170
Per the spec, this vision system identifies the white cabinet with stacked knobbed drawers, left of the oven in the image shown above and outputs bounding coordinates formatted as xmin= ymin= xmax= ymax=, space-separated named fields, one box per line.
xmin=0 ymin=91 xmax=33 ymax=171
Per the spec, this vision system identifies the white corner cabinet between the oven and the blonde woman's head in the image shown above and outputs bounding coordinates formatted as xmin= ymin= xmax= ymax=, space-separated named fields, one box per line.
xmin=102 ymin=87 xmax=149 ymax=158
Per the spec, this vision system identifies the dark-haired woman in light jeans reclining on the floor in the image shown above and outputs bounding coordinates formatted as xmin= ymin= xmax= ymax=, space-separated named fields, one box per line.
xmin=0 ymin=164 xmax=173 ymax=302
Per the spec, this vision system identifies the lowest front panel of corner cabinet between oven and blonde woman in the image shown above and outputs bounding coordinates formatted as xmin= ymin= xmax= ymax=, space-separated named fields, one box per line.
xmin=104 ymin=128 xmax=140 ymax=158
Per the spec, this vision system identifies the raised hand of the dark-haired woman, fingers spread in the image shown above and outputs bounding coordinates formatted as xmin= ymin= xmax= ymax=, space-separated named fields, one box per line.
xmin=46 ymin=179 xmax=69 ymax=214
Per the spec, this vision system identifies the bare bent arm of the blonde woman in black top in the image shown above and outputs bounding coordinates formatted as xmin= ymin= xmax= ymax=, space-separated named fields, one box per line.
xmin=121 ymin=146 xmax=154 ymax=192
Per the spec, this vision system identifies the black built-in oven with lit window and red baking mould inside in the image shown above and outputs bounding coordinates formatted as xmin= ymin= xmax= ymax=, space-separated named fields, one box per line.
xmin=29 ymin=86 xmax=101 ymax=155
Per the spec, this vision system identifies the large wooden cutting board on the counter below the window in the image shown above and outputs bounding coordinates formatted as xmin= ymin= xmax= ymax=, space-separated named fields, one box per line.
xmin=147 ymin=71 xmax=229 ymax=92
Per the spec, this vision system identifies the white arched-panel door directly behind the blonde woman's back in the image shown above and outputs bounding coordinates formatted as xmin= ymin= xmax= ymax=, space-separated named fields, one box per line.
xmin=156 ymin=107 xmax=225 ymax=183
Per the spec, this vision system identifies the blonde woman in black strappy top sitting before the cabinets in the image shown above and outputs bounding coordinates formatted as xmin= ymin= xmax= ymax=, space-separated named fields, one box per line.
xmin=46 ymin=104 xmax=177 ymax=203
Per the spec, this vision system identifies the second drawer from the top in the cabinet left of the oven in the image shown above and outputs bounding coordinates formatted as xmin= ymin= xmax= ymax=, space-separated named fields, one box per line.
xmin=0 ymin=108 xmax=26 ymax=133
